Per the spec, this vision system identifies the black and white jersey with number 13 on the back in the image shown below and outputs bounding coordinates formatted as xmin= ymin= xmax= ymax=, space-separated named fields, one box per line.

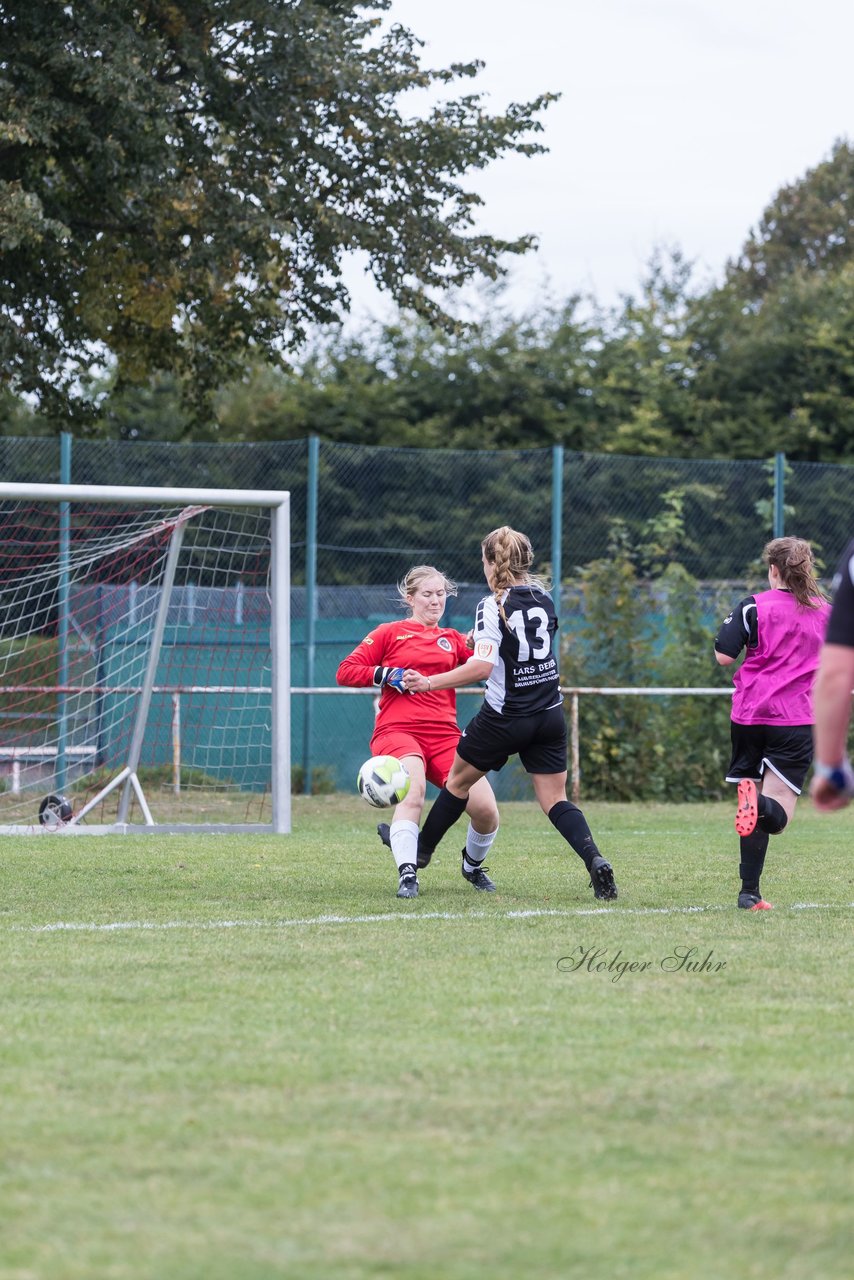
xmin=472 ymin=586 xmax=563 ymax=716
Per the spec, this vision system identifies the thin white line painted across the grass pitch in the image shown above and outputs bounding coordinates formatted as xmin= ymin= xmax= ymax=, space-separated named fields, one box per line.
xmin=8 ymin=902 xmax=854 ymax=933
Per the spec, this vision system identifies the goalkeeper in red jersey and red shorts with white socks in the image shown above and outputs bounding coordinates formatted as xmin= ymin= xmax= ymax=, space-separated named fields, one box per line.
xmin=337 ymin=564 xmax=498 ymax=897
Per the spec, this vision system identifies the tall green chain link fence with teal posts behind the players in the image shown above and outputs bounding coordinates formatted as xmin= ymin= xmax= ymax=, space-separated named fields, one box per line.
xmin=0 ymin=436 xmax=854 ymax=794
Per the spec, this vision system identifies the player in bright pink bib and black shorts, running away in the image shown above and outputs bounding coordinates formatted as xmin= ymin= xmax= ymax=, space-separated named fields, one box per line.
xmin=714 ymin=538 xmax=830 ymax=911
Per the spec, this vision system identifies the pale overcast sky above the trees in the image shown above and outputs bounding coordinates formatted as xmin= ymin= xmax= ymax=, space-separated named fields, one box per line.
xmin=340 ymin=0 xmax=854 ymax=316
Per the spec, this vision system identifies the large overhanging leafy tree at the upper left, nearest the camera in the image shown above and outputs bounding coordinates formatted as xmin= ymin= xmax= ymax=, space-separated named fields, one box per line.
xmin=0 ymin=0 xmax=552 ymax=417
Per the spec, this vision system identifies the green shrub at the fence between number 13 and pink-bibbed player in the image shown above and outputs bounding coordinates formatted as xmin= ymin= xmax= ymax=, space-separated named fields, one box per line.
xmin=561 ymin=512 xmax=730 ymax=800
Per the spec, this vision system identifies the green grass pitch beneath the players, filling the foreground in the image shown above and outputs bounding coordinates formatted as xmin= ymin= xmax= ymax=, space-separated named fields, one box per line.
xmin=0 ymin=796 xmax=854 ymax=1280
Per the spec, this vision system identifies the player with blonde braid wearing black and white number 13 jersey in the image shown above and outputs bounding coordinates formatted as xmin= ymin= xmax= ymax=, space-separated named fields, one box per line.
xmin=403 ymin=525 xmax=617 ymax=899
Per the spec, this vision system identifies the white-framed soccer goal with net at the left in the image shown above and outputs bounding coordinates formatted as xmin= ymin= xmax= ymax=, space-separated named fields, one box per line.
xmin=0 ymin=484 xmax=291 ymax=835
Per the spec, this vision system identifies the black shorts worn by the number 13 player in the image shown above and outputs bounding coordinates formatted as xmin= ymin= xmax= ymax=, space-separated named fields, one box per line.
xmin=457 ymin=703 xmax=566 ymax=773
